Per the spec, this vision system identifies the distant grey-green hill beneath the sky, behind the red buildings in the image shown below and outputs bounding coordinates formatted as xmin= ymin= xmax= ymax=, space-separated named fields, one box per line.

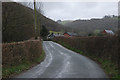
xmin=60 ymin=16 xmax=118 ymax=35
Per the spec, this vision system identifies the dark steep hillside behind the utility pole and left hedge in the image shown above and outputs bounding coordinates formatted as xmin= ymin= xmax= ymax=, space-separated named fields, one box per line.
xmin=2 ymin=2 xmax=63 ymax=42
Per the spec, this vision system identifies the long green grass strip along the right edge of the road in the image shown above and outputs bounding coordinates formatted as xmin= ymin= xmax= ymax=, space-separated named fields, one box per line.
xmin=55 ymin=41 xmax=120 ymax=80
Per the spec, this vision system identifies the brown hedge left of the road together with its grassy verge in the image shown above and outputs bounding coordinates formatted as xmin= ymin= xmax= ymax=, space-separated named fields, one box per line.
xmin=2 ymin=40 xmax=45 ymax=78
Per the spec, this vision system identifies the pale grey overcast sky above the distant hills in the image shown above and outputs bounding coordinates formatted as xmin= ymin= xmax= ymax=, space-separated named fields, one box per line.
xmin=43 ymin=2 xmax=118 ymax=21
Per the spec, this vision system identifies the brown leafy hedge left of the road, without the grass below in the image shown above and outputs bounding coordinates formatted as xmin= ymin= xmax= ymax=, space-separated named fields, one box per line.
xmin=2 ymin=40 xmax=42 ymax=68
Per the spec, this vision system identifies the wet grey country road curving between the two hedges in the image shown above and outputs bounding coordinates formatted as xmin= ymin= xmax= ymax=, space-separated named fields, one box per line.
xmin=16 ymin=41 xmax=107 ymax=78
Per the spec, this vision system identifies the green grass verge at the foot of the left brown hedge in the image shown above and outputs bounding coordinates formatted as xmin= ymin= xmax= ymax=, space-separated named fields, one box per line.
xmin=2 ymin=51 xmax=45 ymax=78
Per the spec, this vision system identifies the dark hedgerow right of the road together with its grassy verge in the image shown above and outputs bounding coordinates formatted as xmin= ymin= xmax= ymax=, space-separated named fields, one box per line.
xmin=53 ymin=36 xmax=120 ymax=78
